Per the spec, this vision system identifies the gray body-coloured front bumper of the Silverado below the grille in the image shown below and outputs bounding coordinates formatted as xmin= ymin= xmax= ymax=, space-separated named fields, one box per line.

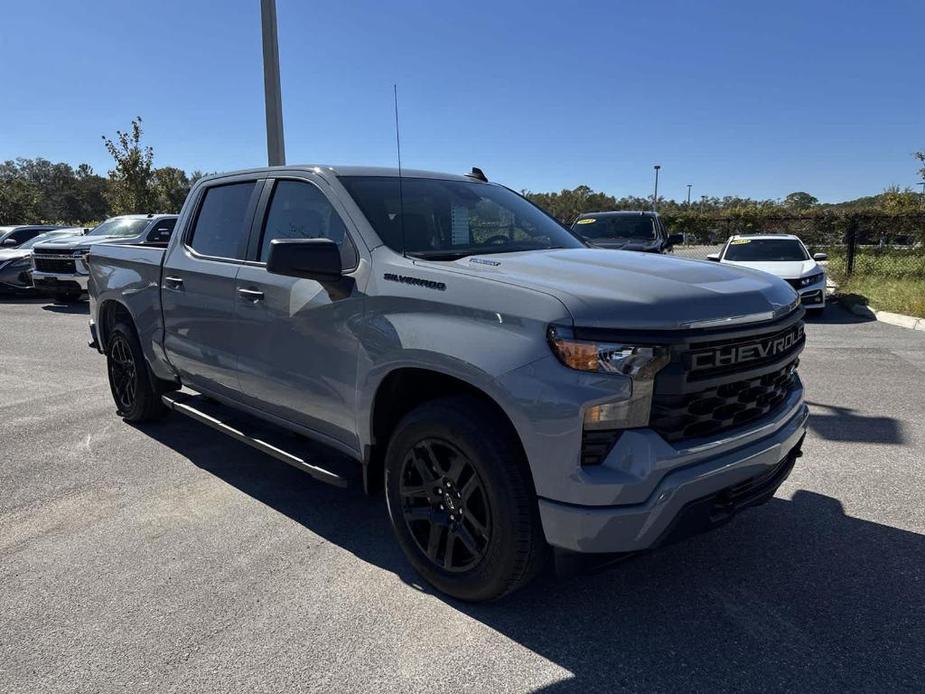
xmin=539 ymin=398 xmax=809 ymax=553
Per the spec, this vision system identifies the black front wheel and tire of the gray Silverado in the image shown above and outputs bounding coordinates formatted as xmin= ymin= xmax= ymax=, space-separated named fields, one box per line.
xmin=385 ymin=397 xmax=548 ymax=602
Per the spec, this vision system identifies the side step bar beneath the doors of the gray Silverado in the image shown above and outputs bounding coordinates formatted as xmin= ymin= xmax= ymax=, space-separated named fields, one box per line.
xmin=161 ymin=391 xmax=359 ymax=487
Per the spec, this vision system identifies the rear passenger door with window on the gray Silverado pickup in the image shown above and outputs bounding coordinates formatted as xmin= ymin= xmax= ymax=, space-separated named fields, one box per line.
xmin=161 ymin=177 xmax=263 ymax=398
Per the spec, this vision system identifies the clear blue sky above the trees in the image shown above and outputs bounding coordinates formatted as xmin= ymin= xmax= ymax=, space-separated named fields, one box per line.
xmin=0 ymin=0 xmax=925 ymax=201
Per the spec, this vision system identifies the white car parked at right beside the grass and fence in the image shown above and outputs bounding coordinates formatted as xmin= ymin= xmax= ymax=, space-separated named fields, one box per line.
xmin=707 ymin=234 xmax=828 ymax=311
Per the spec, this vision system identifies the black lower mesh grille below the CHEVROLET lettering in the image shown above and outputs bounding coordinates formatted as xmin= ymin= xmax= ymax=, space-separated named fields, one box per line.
xmin=650 ymin=359 xmax=799 ymax=441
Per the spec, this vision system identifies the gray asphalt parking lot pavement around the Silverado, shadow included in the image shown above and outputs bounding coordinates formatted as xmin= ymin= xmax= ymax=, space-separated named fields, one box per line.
xmin=0 ymin=300 xmax=925 ymax=694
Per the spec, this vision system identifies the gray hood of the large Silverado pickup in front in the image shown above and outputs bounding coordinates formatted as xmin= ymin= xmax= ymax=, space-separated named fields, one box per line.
xmin=444 ymin=248 xmax=797 ymax=330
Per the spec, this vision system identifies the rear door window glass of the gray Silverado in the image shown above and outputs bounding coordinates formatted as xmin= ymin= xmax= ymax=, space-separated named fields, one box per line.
xmin=187 ymin=181 xmax=257 ymax=260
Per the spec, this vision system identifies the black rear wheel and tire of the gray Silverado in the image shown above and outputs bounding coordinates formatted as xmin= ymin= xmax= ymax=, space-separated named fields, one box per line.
xmin=106 ymin=322 xmax=169 ymax=423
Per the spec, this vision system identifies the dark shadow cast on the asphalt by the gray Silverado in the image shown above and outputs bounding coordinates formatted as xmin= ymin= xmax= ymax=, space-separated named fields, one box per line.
xmin=134 ymin=418 xmax=925 ymax=692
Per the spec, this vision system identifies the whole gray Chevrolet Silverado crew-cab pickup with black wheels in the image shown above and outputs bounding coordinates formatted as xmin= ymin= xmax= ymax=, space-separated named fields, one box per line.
xmin=89 ymin=166 xmax=807 ymax=601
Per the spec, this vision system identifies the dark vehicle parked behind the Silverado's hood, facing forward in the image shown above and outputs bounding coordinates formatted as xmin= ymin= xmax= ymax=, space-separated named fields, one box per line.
xmin=572 ymin=212 xmax=683 ymax=253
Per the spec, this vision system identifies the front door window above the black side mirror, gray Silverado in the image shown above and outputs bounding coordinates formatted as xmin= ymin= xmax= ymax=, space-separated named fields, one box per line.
xmin=257 ymin=180 xmax=357 ymax=269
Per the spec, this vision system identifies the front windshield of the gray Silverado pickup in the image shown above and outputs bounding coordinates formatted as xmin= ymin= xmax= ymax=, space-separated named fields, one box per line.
xmin=340 ymin=176 xmax=583 ymax=260
